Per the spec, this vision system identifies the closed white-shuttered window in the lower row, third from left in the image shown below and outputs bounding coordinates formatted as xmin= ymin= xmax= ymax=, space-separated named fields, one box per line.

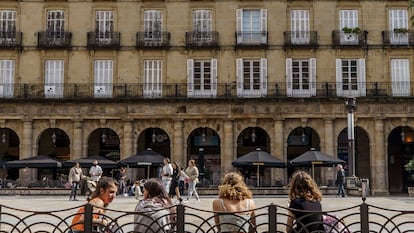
xmin=94 ymin=60 xmax=113 ymax=98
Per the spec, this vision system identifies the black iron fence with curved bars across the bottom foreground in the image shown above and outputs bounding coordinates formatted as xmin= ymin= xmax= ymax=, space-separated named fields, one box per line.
xmin=0 ymin=200 xmax=414 ymax=233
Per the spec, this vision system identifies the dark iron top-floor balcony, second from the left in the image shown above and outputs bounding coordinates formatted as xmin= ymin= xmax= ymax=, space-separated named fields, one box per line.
xmin=37 ymin=31 xmax=72 ymax=49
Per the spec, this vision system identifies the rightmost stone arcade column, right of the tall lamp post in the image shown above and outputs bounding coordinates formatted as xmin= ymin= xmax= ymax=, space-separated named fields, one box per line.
xmin=370 ymin=118 xmax=389 ymax=195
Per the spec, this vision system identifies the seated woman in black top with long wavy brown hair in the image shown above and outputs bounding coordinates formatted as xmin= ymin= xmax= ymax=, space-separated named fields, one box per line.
xmin=286 ymin=171 xmax=324 ymax=233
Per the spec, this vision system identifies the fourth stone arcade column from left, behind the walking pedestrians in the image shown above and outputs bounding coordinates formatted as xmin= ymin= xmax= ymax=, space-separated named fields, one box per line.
xmin=171 ymin=120 xmax=187 ymax=167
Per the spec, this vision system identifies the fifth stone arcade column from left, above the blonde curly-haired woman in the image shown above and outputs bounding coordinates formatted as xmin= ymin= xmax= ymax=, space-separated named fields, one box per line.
xmin=220 ymin=119 xmax=233 ymax=176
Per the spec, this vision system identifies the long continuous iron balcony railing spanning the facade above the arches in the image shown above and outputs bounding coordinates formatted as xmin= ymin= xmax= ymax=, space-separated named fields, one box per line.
xmin=0 ymin=82 xmax=414 ymax=100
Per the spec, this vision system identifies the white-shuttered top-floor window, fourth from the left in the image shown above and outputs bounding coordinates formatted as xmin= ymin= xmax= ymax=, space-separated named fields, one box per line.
xmin=144 ymin=10 xmax=163 ymax=41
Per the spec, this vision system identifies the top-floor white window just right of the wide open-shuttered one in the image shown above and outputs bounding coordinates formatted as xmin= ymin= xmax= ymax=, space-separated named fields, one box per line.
xmin=290 ymin=10 xmax=310 ymax=44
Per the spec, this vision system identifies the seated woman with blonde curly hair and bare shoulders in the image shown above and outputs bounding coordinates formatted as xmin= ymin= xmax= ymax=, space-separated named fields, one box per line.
xmin=213 ymin=172 xmax=256 ymax=233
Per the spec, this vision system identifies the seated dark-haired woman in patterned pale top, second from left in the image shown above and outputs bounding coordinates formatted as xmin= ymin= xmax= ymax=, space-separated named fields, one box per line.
xmin=134 ymin=178 xmax=175 ymax=233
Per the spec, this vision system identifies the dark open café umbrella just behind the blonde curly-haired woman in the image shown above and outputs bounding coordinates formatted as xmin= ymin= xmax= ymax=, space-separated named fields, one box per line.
xmin=232 ymin=148 xmax=286 ymax=186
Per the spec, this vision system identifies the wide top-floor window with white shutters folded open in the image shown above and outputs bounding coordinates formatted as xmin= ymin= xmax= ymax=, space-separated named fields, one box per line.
xmin=237 ymin=9 xmax=267 ymax=44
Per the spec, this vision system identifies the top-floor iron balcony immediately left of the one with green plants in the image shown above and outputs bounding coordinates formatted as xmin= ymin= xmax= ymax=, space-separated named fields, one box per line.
xmin=283 ymin=31 xmax=319 ymax=49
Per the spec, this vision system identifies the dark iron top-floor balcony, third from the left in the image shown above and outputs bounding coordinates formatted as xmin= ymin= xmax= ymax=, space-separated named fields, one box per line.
xmin=87 ymin=32 xmax=121 ymax=50
